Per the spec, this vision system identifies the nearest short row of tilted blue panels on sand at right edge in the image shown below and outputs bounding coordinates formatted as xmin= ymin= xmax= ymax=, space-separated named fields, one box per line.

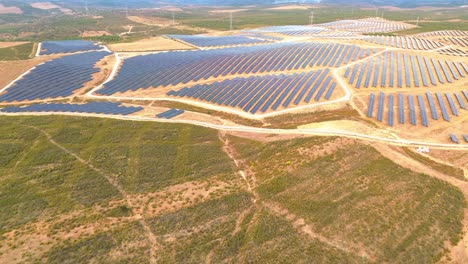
xmin=367 ymin=91 xmax=468 ymax=127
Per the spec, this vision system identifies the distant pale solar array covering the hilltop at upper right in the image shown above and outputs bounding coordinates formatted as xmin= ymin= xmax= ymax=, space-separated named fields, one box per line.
xmin=316 ymin=18 xmax=411 ymax=33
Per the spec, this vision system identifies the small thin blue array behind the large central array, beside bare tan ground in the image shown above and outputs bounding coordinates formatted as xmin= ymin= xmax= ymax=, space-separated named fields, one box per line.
xmin=166 ymin=35 xmax=271 ymax=47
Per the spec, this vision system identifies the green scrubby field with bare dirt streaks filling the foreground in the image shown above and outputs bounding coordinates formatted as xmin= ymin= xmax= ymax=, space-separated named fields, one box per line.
xmin=0 ymin=117 xmax=464 ymax=263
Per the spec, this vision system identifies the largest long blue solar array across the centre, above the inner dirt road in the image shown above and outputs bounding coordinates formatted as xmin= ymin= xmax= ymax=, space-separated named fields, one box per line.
xmin=97 ymin=43 xmax=375 ymax=95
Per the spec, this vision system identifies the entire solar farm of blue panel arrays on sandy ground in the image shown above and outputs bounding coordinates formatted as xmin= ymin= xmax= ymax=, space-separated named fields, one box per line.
xmin=0 ymin=18 xmax=468 ymax=144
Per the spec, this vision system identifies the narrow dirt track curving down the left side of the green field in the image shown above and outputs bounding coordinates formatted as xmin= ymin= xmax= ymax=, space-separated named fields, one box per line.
xmin=12 ymin=124 xmax=159 ymax=263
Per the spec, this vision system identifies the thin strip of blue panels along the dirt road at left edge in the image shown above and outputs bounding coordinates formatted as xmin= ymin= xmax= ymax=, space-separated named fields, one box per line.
xmin=0 ymin=102 xmax=143 ymax=115
